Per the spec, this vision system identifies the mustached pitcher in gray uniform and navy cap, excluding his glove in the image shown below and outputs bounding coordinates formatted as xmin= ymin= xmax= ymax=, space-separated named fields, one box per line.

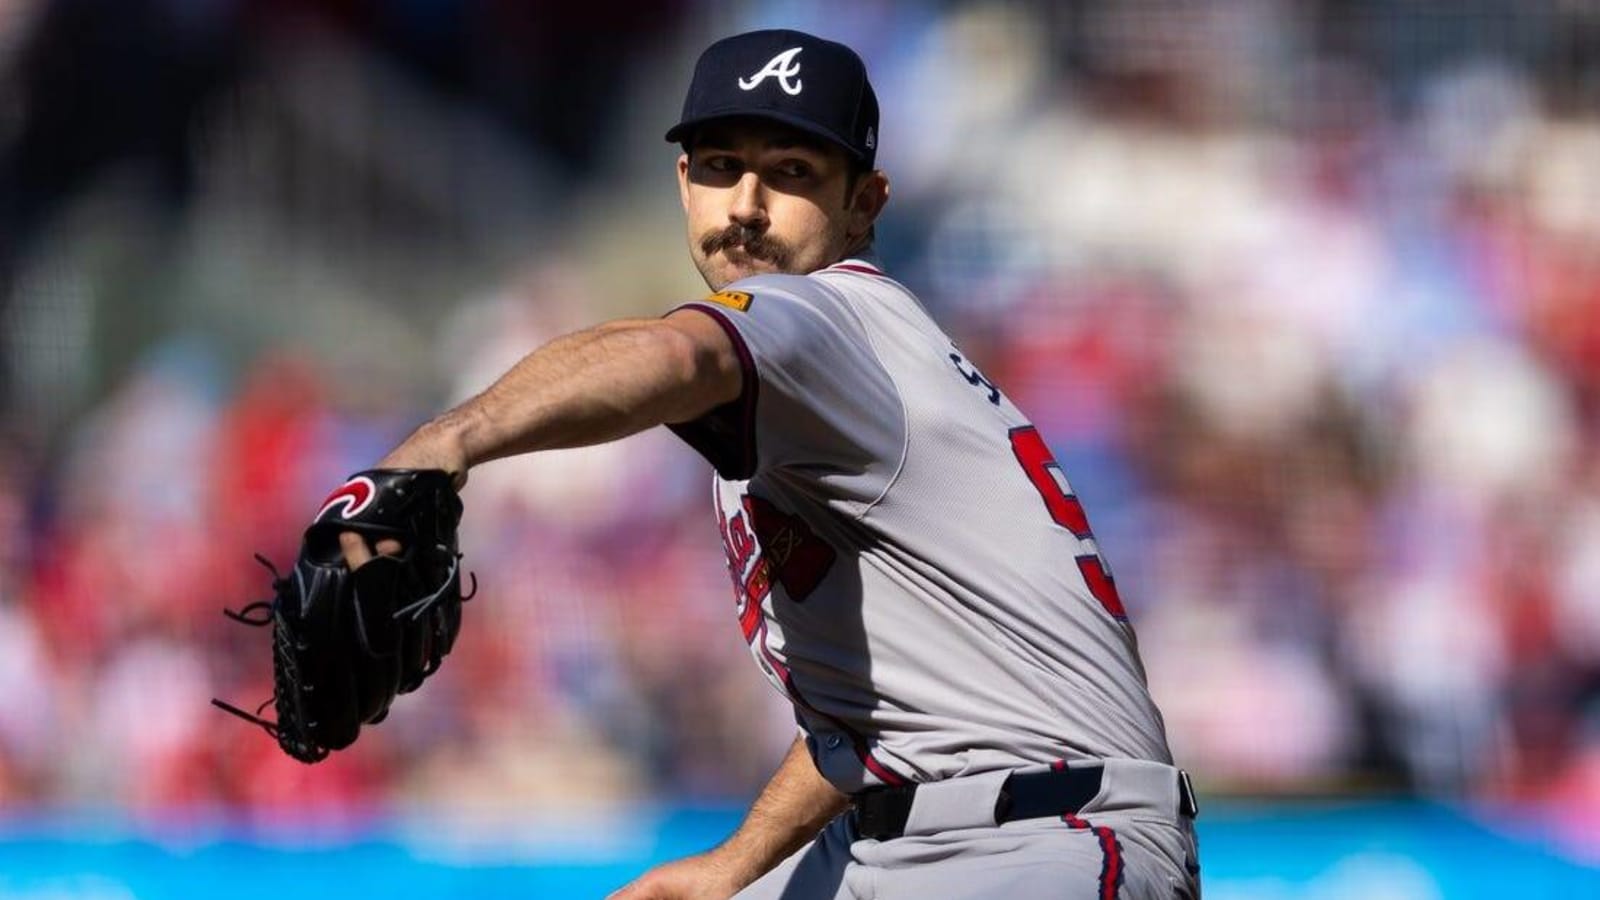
xmin=344 ymin=30 xmax=1198 ymax=900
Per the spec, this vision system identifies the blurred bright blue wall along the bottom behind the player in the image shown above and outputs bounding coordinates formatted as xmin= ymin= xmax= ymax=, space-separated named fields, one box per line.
xmin=0 ymin=802 xmax=1600 ymax=900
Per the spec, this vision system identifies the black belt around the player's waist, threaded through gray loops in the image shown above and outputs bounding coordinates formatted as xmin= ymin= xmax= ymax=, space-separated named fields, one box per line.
xmin=851 ymin=765 xmax=1200 ymax=841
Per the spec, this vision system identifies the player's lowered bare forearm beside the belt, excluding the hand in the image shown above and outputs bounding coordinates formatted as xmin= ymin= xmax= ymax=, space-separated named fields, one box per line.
xmin=714 ymin=738 xmax=850 ymax=886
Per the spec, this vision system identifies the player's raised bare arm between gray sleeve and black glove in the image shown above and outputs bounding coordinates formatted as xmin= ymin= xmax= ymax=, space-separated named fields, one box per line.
xmin=384 ymin=314 xmax=739 ymax=472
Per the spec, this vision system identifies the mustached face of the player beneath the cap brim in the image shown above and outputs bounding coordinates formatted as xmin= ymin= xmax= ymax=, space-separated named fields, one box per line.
xmin=678 ymin=119 xmax=888 ymax=290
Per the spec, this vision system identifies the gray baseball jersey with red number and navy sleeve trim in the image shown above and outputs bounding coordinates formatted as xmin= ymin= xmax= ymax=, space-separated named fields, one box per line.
xmin=674 ymin=259 xmax=1171 ymax=793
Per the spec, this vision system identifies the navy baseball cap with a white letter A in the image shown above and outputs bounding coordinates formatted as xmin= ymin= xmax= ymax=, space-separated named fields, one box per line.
xmin=667 ymin=29 xmax=878 ymax=168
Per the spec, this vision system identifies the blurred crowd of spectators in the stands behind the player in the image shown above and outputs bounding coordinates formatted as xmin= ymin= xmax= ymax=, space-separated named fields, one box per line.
xmin=0 ymin=0 xmax=1600 ymax=858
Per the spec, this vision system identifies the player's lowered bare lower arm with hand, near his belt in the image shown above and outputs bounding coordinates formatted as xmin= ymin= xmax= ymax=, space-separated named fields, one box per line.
xmin=611 ymin=738 xmax=850 ymax=900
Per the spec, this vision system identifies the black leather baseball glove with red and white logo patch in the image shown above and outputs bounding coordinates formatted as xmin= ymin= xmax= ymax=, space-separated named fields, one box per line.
xmin=213 ymin=469 xmax=477 ymax=762
